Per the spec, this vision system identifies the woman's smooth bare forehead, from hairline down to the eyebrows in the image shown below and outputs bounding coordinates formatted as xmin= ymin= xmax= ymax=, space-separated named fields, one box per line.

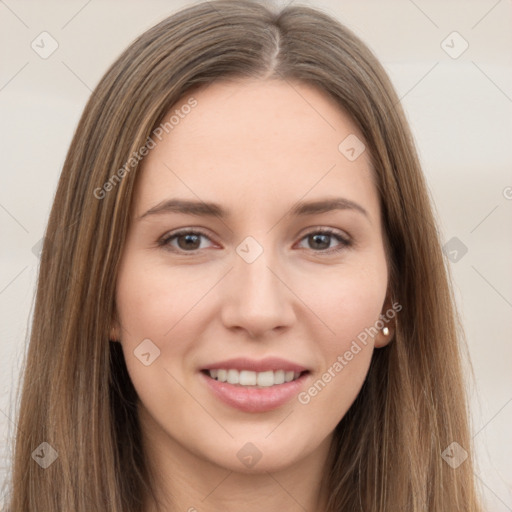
xmin=135 ymin=80 xmax=378 ymax=222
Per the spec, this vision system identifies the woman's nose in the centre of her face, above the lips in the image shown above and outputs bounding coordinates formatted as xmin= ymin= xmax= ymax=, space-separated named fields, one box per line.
xmin=221 ymin=245 xmax=295 ymax=338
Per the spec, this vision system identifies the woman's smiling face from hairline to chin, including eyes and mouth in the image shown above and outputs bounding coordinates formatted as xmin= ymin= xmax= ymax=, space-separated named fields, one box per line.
xmin=114 ymin=81 xmax=391 ymax=472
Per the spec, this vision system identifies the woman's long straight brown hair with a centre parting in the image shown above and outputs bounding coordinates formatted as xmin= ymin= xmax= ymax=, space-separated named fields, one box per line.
xmin=8 ymin=0 xmax=481 ymax=512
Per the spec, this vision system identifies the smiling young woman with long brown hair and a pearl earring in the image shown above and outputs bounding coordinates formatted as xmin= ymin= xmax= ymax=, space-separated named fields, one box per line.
xmin=4 ymin=0 xmax=481 ymax=512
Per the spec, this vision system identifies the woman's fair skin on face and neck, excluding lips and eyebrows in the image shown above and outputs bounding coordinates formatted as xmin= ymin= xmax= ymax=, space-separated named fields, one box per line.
xmin=112 ymin=80 xmax=393 ymax=512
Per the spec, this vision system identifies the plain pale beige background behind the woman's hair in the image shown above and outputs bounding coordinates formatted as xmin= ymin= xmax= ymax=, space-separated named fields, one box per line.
xmin=0 ymin=0 xmax=512 ymax=512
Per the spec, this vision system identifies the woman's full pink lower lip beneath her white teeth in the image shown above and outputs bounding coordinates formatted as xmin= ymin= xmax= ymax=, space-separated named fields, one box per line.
xmin=201 ymin=372 xmax=309 ymax=412
